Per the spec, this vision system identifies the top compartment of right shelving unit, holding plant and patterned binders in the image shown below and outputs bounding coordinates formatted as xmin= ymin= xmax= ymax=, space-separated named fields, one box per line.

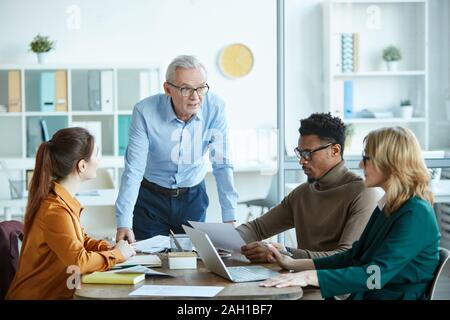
xmin=330 ymin=1 xmax=427 ymax=73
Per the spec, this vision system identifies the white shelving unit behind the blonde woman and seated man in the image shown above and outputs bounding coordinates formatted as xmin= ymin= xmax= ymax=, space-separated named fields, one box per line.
xmin=323 ymin=0 xmax=429 ymax=155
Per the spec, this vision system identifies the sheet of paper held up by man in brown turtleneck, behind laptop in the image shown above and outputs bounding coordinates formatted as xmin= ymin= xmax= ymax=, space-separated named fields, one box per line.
xmin=189 ymin=221 xmax=245 ymax=252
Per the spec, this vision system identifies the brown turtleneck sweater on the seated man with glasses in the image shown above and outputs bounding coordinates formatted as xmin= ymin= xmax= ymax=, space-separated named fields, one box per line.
xmin=237 ymin=161 xmax=381 ymax=259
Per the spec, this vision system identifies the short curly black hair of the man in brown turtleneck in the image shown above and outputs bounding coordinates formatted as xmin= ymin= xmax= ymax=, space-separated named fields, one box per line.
xmin=298 ymin=112 xmax=345 ymax=156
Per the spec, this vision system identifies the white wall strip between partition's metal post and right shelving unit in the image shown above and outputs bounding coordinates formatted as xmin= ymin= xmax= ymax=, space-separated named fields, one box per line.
xmin=285 ymin=0 xmax=324 ymax=155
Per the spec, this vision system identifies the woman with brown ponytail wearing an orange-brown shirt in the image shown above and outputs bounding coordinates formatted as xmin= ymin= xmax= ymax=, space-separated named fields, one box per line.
xmin=6 ymin=128 xmax=135 ymax=299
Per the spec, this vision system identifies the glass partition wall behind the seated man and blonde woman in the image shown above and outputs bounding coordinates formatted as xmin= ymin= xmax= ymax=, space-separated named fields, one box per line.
xmin=278 ymin=0 xmax=450 ymax=246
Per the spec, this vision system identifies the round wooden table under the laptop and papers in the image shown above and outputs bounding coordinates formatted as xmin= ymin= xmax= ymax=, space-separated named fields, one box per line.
xmin=74 ymin=254 xmax=321 ymax=300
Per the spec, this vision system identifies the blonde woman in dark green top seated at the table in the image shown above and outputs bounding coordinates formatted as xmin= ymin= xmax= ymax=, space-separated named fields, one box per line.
xmin=261 ymin=127 xmax=440 ymax=299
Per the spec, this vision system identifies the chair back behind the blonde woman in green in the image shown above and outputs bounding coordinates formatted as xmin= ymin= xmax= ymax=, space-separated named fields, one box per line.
xmin=430 ymin=248 xmax=450 ymax=300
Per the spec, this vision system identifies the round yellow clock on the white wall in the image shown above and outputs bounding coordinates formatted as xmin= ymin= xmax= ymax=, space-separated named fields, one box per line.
xmin=219 ymin=43 xmax=253 ymax=78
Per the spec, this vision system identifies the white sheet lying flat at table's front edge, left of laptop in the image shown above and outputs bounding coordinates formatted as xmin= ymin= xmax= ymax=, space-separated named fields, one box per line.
xmin=129 ymin=285 xmax=224 ymax=297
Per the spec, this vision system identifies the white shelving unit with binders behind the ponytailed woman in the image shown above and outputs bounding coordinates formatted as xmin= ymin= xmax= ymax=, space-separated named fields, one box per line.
xmin=0 ymin=64 xmax=163 ymax=186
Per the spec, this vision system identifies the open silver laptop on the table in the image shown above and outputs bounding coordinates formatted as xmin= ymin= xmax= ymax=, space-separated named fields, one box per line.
xmin=183 ymin=225 xmax=279 ymax=282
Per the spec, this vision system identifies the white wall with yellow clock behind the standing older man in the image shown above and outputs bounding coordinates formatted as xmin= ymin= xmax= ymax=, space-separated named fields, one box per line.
xmin=0 ymin=0 xmax=276 ymax=128
